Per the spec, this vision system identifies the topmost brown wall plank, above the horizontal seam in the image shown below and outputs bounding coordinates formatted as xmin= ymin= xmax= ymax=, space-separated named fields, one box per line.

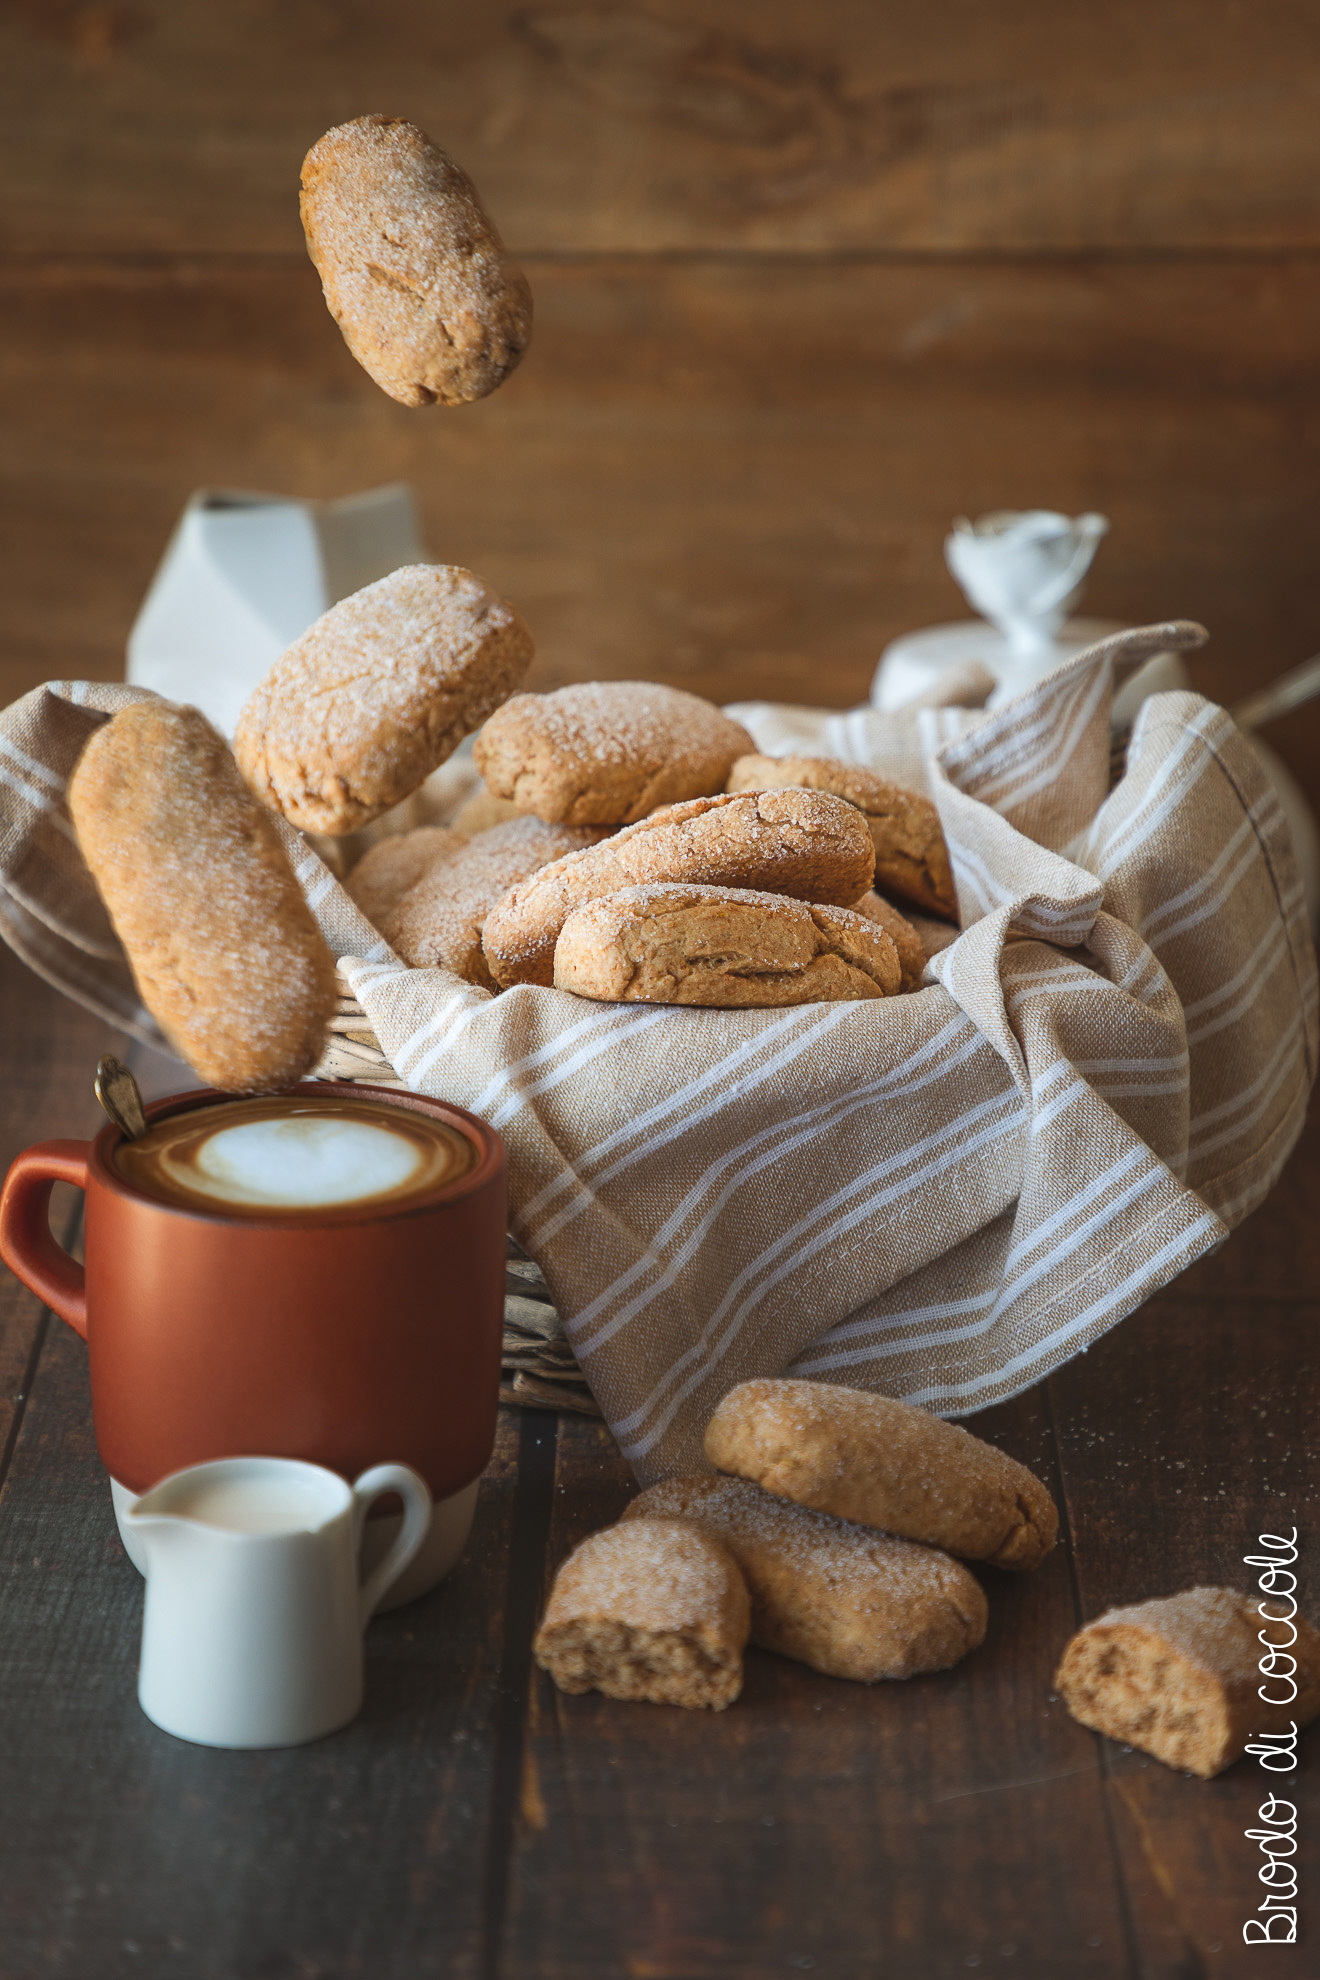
xmin=0 ymin=0 xmax=1320 ymax=251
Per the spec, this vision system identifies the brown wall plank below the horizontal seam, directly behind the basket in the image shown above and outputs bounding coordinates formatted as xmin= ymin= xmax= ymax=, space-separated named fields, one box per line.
xmin=0 ymin=257 xmax=1320 ymax=782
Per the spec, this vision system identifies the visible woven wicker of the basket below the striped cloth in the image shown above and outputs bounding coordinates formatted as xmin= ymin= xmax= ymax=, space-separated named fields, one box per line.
xmin=313 ymin=976 xmax=600 ymax=1416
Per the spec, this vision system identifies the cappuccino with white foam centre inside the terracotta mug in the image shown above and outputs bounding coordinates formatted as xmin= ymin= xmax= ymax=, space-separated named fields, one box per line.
xmin=115 ymin=1089 xmax=477 ymax=1218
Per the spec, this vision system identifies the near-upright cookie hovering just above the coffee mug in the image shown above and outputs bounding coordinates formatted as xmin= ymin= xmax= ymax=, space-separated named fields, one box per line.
xmin=69 ymin=701 xmax=336 ymax=1093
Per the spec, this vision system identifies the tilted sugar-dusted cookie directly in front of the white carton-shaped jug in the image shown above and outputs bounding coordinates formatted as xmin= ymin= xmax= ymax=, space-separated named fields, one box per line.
xmin=234 ymin=564 xmax=532 ymax=838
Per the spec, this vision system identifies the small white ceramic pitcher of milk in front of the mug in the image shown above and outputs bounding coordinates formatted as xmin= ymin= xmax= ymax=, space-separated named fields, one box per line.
xmin=127 ymin=1457 xmax=431 ymax=1746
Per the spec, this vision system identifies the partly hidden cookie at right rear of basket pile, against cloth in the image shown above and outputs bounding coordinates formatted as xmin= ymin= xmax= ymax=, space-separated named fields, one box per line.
xmin=728 ymin=756 xmax=958 ymax=921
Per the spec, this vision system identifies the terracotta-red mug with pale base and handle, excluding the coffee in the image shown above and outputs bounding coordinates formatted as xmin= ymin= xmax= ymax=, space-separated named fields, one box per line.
xmin=0 ymin=1081 xmax=507 ymax=1602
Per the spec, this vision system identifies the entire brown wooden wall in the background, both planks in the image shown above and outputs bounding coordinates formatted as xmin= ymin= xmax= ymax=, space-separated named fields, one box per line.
xmin=0 ymin=0 xmax=1320 ymax=788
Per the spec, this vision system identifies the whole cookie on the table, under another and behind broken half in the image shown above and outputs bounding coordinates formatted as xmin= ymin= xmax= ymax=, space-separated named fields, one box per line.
xmin=623 ymin=1477 xmax=988 ymax=1685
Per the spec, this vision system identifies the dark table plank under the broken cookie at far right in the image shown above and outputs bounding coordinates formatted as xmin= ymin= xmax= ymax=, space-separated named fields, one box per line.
xmin=1049 ymin=1275 xmax=1320 ymax=1980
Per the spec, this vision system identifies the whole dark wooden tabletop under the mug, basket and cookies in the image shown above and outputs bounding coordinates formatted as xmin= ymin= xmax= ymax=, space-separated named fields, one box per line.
xmin=0 ymin=950 xmax=1320 ymax=1980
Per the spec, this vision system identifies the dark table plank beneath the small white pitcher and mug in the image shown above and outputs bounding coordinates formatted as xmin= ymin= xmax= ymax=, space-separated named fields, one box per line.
xmin=0 ymin=1283 xmax=519 ymax=1980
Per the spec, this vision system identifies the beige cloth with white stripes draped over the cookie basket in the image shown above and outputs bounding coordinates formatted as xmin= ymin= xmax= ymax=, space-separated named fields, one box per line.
xmin=0 ymin=624 xmax=1316 ymax=1479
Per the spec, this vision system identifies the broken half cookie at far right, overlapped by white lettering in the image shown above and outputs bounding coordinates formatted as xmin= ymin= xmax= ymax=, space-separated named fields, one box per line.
xmin=1055 ymin=1588 xmax=1320 ymax=1780
